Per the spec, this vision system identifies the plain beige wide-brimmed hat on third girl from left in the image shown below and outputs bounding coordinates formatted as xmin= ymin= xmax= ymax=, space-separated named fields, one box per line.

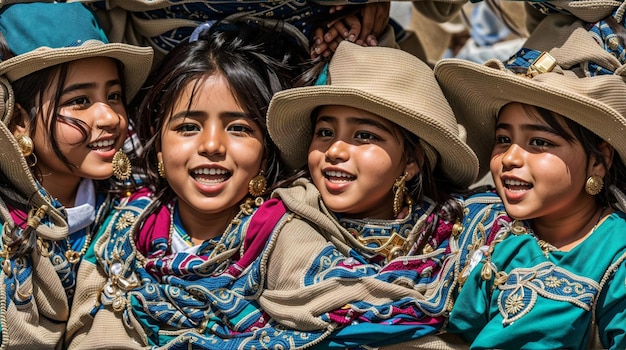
xmin=267 ymin=41 xmax=478 ymax=187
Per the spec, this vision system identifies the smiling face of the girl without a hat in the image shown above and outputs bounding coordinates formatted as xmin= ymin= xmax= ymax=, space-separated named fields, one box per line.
xmin=157 ymin=75 xmax=264 ymax=221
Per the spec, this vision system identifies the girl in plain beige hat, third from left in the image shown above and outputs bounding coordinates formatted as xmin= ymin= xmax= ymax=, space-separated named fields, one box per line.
xmin=259 ymin=42 xmax=504 ymax=348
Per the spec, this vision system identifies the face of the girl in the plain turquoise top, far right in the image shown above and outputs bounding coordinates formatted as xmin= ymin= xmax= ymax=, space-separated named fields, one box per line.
xmin=491 ymin=103 xmax=594 ymax=220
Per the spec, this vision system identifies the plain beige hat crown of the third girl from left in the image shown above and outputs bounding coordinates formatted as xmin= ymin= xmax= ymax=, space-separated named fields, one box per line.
xmin=328 ymin=44 xmax=458 ymax=136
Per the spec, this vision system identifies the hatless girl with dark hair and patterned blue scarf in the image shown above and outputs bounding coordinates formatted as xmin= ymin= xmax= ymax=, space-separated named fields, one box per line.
xmin=68 ymin=17 xmax=308 ymax=348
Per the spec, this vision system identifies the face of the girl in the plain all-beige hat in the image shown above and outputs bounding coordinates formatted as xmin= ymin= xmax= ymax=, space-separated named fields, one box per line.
xmin=308 ymin=106 xmax=417 ymax=219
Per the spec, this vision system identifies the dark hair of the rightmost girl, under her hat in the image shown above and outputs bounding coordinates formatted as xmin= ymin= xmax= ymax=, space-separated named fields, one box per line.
xmin=522 ymin=104 xmax=626 ymax=209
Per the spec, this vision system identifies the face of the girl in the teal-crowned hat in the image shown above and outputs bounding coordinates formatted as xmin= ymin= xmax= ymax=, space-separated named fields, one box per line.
xmin=31 ymin=57 xmax=128 ymax=188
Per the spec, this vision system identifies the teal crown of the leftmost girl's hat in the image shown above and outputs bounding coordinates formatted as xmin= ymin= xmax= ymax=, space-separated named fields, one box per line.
xmin=0 ymin=2 xmax=108 ymax=55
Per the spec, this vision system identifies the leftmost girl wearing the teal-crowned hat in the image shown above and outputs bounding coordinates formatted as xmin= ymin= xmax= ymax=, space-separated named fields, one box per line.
xmin=0 ymin=3 xmax=152 ymax=347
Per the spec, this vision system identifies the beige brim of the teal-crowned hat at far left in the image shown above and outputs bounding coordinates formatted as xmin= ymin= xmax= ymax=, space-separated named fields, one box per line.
xmin=0 ymin=40 xmax=153 ymax=101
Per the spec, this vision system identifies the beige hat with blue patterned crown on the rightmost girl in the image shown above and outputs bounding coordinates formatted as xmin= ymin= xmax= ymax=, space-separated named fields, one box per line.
xmin=434 ymin=15 xmax=626 ymax=175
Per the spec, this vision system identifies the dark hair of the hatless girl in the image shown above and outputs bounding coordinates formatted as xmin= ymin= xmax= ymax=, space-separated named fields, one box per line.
xmin=136 ymin=19 xmax=309 ymax=208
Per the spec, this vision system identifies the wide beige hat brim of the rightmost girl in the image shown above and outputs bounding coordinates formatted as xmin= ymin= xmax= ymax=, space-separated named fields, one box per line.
xmin=434 ymin=59 xmax=626 ymax=177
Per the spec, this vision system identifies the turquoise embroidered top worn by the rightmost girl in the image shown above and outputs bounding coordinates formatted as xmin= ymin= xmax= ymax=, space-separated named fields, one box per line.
xmin=448 ymin=212 xmax=626 ymax=349
